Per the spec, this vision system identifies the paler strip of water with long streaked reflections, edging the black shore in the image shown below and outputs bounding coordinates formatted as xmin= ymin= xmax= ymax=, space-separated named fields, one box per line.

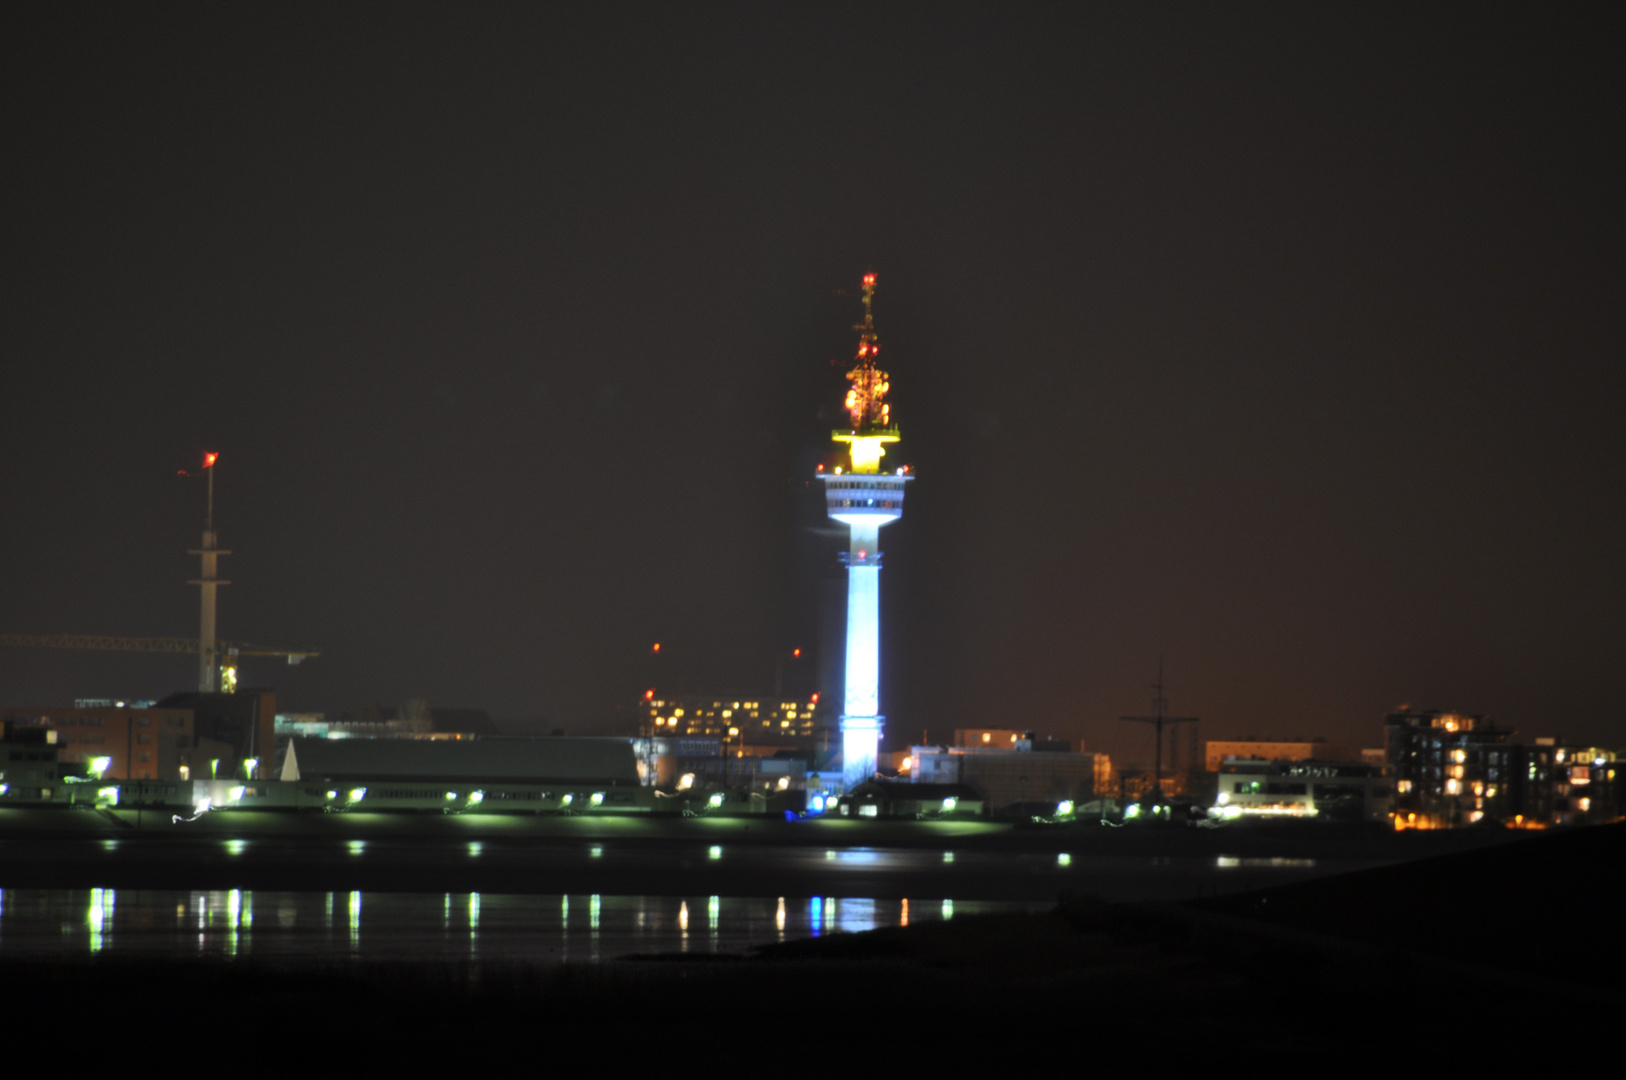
xmin=0 ymin=888 xmax=1046 ymax=965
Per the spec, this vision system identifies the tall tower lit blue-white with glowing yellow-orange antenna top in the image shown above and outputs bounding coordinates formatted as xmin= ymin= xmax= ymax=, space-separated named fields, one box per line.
xmin=820 ymin=273 xmax=912 ymax=790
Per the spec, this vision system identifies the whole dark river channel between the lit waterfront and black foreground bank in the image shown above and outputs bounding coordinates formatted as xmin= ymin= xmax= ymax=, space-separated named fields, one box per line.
xmin=0 ymin=836 xmax=1374 ymax=965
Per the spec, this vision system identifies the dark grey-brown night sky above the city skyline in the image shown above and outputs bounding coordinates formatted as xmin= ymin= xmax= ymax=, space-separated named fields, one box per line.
xmin=0 ymin=3 xmax=1626 ymax=753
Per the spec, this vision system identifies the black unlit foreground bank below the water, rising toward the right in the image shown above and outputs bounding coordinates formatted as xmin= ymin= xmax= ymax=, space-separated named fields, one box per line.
xmin=0 ymin=825 xmax=1626 ymax=1075
